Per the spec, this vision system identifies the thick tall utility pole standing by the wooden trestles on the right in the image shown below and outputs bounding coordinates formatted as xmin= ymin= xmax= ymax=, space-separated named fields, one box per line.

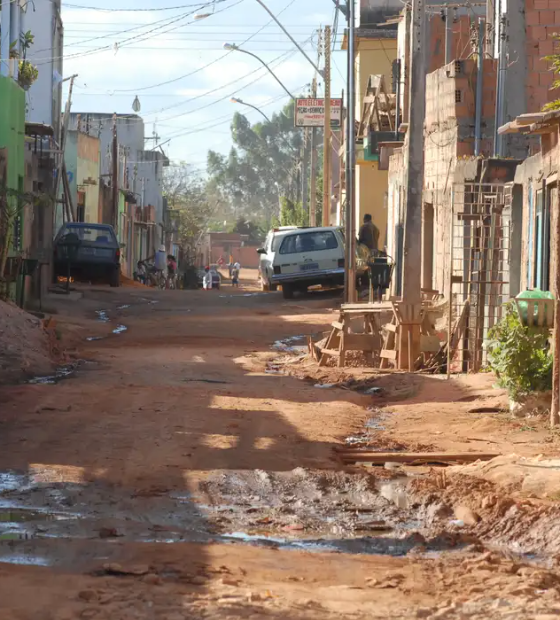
xmin=399 ymin=0 xmax=426 ymax=370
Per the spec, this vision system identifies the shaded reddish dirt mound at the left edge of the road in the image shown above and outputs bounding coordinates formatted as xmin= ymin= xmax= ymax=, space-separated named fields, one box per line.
xmin=0 ymin=301 xmax=54 ymax=384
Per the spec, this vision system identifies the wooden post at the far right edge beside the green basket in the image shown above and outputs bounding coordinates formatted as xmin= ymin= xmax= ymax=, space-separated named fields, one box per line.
xmin=550 ymin=125 xmax=560 ymax=427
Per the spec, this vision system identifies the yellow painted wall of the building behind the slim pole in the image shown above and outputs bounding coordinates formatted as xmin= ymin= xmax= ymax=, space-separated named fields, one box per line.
xmin=356 ymin=39 xmax=397 ymax=249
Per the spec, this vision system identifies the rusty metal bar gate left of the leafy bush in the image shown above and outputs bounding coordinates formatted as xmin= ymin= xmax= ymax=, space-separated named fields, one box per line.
xmin=448 ymin=183 xmax=512 ymax=373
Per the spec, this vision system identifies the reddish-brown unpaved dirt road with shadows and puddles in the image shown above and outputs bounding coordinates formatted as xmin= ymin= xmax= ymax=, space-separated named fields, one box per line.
xmin=0 ymin=278 xmax=560 ymax=620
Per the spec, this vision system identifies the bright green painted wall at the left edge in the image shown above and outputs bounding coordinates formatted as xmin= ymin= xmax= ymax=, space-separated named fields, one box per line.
xmin=0 ymin=76 xmax=25 ymax=250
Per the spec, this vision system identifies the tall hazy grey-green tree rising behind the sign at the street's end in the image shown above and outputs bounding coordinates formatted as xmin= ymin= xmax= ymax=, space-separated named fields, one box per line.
xmin=207 ymin=102 xmax=303 ymax=227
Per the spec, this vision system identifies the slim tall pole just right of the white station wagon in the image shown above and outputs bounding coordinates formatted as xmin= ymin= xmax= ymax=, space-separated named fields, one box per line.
xmin=344 ymin=0 xmax=356 ymax=303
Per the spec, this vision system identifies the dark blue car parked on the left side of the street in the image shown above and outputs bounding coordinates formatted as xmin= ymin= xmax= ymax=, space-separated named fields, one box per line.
xmin=54 ymin=222 xmax=121 ymax=286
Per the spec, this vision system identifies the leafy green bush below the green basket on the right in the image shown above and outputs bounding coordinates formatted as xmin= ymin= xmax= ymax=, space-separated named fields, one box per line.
xmin=487 ymin=302 xmax=552 ymax=400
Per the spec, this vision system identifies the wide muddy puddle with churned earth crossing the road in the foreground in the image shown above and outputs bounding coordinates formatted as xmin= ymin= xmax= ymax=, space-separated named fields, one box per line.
xmin=0 ymin=468 xmax=556 ymax=565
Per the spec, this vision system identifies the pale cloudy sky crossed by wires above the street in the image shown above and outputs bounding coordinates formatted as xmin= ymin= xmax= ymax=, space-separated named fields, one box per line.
xmin=57 ymin=0 xmax=346 ymax=173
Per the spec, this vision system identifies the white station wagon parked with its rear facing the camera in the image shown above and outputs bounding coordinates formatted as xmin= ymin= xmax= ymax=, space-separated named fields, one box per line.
xmin=257 ymin=227 xmax=344 ymax=299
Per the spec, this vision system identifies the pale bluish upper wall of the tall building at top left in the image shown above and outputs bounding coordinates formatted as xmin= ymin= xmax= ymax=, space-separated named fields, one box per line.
xmin=21 ymin=0 xmax=63 ymax=140
